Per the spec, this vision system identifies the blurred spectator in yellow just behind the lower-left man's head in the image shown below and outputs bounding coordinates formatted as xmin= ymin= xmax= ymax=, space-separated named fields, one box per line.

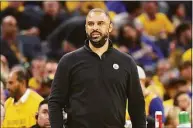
xmin=29 ymin=57 xmax=46 ymax=91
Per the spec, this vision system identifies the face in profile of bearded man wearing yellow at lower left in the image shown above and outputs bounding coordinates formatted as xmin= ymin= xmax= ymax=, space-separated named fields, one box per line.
xmin=7 ymin=72 xmax=21 ymax=98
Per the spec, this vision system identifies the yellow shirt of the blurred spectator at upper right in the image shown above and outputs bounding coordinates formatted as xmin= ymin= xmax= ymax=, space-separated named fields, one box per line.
xmin=137 ymin=13 xmax=174 ymax=37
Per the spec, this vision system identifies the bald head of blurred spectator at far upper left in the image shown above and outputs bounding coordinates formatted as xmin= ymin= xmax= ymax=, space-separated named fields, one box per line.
xmin=2 ymin=16 xmax=17 ymax=37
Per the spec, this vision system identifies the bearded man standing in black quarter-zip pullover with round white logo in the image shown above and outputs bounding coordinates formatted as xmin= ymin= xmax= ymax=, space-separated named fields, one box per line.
xmin=48 ymin=9 xmax=146 ymax=128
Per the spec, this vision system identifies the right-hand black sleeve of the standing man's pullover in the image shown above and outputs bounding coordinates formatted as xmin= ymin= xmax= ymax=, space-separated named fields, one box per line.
xmin=127 ymin=59 xmax=146 ymax=128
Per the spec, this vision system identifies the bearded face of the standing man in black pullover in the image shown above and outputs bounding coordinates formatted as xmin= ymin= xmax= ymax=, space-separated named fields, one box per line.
xmin=85 ymin=12 xmax=112 ymax=45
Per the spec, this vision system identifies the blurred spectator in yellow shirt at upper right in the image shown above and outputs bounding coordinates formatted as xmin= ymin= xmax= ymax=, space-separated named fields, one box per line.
xmin=136 ymin=1 xmax=174 ymax=40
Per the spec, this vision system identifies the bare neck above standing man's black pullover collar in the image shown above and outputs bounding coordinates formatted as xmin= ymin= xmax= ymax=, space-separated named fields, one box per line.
xmin=89 ymin=40 xmax=109 ymax=58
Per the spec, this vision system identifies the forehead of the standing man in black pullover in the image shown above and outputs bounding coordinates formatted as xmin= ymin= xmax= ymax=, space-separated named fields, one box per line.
xmin=87 ymin=11 xmax=109 ymax=21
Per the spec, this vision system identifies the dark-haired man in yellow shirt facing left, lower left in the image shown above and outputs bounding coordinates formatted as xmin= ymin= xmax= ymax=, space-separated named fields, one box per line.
xmin=3 ymin=67 xmax=43 ymax=128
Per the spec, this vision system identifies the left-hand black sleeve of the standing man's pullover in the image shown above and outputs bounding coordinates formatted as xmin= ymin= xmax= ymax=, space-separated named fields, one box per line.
xmin=48 ymin=55 xmax=70 ymax=128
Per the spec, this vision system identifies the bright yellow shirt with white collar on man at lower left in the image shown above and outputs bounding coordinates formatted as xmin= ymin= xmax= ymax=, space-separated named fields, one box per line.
xmin=2 ymin=89 xmax=43 ymax=128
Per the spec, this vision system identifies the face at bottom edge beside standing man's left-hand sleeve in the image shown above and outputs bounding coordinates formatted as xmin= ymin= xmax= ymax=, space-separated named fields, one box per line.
xmin=37 ymin=104 xmax=51 ymax=128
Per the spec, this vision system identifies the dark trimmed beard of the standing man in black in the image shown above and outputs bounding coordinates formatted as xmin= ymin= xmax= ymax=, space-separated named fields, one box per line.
xmin=87 ymin=32 xmax=108 ymax=48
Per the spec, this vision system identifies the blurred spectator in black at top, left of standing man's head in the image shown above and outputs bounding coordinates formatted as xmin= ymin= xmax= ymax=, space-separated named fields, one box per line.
xmin=38 ymin=1 xmax=69 ymax=41
